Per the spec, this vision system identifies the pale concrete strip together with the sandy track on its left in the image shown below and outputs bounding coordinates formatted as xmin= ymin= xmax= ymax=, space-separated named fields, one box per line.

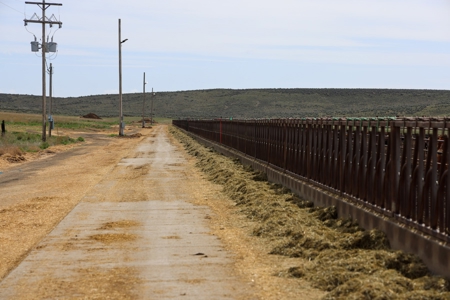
xmin=0 ymin=126 xmax=255 ymax=299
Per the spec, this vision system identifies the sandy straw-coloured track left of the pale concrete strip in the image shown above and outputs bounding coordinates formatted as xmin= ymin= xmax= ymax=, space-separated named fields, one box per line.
xmin=0 ymin=134 xmax=138 ymax=278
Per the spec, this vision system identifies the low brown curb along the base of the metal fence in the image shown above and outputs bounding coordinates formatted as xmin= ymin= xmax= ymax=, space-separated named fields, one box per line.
xmin=177 ymin=123 xmax=450 ymax=277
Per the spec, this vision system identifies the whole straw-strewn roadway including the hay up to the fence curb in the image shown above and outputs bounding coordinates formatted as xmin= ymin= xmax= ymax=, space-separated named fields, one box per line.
xmin=0 ymin=122 xmax=450 ymax=299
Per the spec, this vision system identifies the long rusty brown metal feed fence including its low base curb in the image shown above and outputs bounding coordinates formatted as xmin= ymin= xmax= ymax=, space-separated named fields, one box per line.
xmin=173 ymin=118 xmax=450 ymax=277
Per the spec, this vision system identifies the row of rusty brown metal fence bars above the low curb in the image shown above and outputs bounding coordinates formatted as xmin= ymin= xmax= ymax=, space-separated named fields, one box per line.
xmin=173 ymin=118 xmax=450 ymax=242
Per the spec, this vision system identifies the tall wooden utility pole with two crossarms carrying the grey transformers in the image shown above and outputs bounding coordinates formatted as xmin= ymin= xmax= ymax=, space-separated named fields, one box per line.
xmin=23 ymin=0 xmax=62 ymax=142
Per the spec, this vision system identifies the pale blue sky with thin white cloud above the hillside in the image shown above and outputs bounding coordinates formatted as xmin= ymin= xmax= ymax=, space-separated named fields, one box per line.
xmin=0 ymin=0 xmax=450 ymax=97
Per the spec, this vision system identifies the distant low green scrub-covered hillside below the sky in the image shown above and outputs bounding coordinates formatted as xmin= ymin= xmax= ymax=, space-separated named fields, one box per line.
xmin=0 ymin=89 xmax=450 ymax=118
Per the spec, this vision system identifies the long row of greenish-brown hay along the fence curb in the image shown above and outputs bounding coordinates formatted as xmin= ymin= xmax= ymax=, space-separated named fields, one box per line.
xmin=171 ymin=129 xmax=450 ymax=299
